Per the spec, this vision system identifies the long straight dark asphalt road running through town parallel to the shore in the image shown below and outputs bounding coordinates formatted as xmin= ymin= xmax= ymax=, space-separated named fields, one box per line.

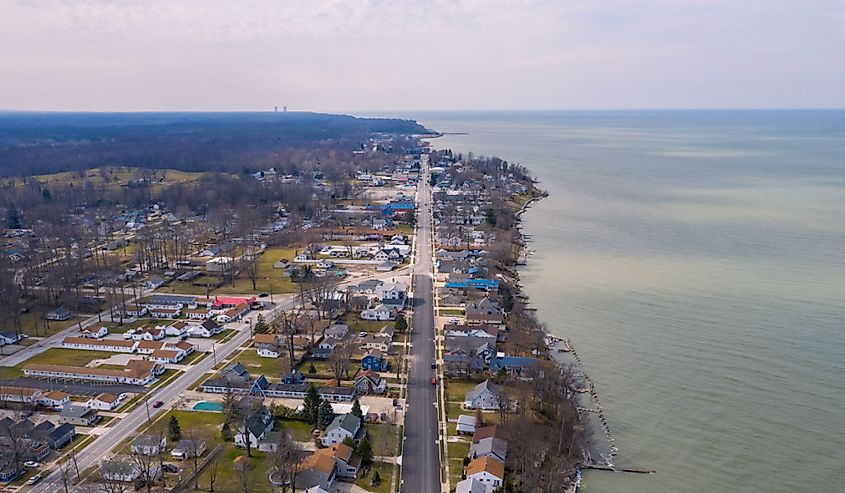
xmin=401 ymin=156 xmax=441 ymax=493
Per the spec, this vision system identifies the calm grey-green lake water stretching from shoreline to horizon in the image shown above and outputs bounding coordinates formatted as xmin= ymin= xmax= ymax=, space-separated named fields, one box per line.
xmin=407 ymin=111 xmax=845 ymax=493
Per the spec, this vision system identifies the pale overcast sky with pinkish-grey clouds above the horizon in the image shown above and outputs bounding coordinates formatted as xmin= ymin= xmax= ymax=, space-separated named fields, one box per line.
xmin=0 ymin=0 xmax=845 ymax=111
